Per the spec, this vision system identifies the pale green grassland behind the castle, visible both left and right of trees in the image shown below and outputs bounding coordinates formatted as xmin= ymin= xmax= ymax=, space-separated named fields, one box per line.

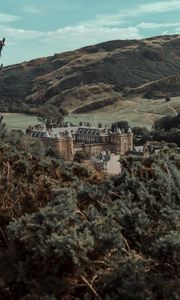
xmin=0 ymin=97 xmax=180 ymax=130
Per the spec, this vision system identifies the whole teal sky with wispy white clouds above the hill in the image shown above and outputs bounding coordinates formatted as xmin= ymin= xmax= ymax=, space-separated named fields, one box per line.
xmin=0 ymin=0 xmax=180 ymax=65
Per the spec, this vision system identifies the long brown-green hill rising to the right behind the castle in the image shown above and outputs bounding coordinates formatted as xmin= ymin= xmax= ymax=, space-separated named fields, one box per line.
xmin=0 ymin=35 xmax=180 ymax=113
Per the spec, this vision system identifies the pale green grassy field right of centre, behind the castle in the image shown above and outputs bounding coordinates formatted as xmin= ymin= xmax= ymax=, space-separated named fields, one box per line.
xmin=84 ymin=97 xmax=180 ymax=129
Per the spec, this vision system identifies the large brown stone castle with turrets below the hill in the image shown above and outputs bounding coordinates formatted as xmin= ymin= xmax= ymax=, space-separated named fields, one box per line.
xmin=27 ymin=125 xmax=133 ymax=160
